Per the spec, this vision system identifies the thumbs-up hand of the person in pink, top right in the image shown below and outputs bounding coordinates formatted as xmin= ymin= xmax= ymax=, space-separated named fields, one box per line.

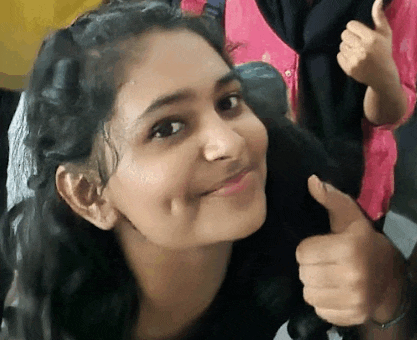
xmin=337 ymin=0 xmax=399 ymax=91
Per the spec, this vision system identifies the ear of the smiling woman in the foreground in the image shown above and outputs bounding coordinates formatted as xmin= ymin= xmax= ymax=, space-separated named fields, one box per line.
xmin=55 ymin=165 xmax=120 ymax=230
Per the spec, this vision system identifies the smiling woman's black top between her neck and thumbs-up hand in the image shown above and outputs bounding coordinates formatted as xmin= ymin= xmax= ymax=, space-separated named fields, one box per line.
xmin=180 ymin=117 xmax=356 ymax=340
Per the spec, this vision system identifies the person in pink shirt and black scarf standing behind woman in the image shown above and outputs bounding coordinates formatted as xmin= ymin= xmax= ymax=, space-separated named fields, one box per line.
xmin=181 ymin=0 xmax=417 ymax=221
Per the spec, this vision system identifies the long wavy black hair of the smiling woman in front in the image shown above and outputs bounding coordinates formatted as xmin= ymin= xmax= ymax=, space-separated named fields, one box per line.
xmin=0 ymin=1 xmax=354 ymax=340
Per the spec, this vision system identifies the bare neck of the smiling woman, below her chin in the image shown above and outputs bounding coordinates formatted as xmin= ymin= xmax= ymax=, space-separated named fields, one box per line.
xmin=117 ymin=227 xmax=232 ymax=340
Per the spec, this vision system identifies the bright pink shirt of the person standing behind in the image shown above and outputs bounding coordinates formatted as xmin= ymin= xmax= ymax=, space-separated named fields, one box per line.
xmin=181 ymin=0 xmax=417 ymax=220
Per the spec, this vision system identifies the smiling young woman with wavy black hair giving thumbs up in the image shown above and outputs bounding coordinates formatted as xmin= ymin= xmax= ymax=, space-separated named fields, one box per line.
xmin=2 ymin=2 xmax=410 ymax=340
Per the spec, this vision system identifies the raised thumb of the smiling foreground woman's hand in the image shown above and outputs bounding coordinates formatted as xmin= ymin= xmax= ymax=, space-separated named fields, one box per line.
xmin=308 ymin=175 xmax=365 ymax=233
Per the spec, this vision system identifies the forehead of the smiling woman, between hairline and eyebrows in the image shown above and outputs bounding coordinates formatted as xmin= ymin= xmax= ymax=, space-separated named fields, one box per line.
xmin=120 ymin=30 xmax=229 ymax=90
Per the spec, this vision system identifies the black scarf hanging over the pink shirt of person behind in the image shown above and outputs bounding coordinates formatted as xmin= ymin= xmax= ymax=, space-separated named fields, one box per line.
xmin=257 ymin=0 xmax=390 ymax=194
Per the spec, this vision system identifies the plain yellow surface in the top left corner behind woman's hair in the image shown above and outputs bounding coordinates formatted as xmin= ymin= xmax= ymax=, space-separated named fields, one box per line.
xmin=0 ymin=0 xmax=101 ymax=89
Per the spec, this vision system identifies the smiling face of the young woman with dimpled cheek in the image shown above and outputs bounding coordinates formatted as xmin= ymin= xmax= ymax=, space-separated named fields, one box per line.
xmin=106 ymin=30 xmax=268 ymax=248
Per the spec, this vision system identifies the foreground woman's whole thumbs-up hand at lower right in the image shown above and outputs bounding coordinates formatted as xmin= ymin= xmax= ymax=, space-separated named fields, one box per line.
xmin=296 ymin=175 xmax=401 ymax=326
